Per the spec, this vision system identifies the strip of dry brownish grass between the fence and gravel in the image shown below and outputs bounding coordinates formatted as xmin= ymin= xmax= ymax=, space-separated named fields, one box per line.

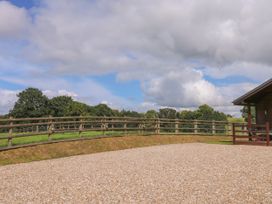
xmin=0 ymin=135 xmax=231 ymax=165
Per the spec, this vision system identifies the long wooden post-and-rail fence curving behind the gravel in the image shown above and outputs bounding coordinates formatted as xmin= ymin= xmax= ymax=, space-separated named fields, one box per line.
xmin=0 ymin=116 xmax=234 ymax=149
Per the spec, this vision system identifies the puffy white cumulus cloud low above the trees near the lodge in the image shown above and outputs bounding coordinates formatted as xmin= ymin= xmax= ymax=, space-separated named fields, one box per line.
xmin=144 ymin=68 xmax=224 ymax=107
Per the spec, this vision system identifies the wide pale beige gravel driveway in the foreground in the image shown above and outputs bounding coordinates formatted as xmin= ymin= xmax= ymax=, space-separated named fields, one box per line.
xmin=0 ymin=143 xmax=272 ymax=204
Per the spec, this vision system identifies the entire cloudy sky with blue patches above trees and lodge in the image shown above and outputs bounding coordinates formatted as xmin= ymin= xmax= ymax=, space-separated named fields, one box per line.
xmin=0 ymin=0 xmax=272 ymax=115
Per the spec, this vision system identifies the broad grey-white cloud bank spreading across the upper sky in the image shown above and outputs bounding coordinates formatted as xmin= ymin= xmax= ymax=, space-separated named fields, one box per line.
xmin=24 ymin=0 xmax=272 ymax=77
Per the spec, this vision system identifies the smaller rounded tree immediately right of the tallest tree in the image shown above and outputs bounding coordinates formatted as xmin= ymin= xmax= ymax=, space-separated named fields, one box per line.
xmin=49 ymin=96 xmax=74 ymax=117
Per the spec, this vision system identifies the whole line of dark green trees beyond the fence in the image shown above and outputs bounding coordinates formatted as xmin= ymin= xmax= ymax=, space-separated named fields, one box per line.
xmin=5 ymin=88 xmax=229 ymax=121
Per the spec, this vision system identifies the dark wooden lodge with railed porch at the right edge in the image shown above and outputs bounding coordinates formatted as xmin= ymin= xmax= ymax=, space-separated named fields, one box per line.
xmin=233 ymin=78 xmax=272 ymax=145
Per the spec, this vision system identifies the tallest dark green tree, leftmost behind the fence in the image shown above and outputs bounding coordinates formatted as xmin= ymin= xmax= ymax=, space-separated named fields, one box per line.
xmin=10 ymin=88 xmax=49 ymax=118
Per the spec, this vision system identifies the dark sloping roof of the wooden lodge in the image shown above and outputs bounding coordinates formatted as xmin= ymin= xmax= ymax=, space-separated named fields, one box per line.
xmin=232 ymin=78 xmax=272 ymax=105
